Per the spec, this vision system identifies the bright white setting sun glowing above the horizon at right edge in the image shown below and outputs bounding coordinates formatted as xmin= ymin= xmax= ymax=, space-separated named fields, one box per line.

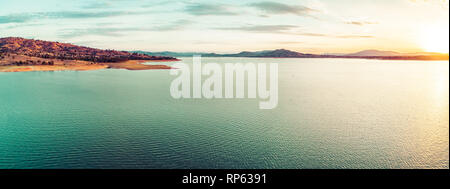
xmin=420 ymin=26 xmax=449 ymax=53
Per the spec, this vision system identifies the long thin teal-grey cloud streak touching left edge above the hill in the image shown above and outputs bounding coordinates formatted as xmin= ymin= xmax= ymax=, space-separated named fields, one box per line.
xmin=0 ymin=11 xmax=143 ymax=24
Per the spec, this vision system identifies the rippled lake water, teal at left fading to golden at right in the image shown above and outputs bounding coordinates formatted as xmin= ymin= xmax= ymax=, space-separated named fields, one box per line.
xmin=0 ymin=58 xmax=449 ymax=169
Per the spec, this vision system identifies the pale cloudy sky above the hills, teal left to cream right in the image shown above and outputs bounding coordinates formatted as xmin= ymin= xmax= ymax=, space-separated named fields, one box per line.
xmin=0 ymin=0 xmax=449 ymax=54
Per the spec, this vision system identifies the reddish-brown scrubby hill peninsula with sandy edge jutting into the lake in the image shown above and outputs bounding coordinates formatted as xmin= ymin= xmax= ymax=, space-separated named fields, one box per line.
xmin=0 ymin=37 xmax=178 ymax=72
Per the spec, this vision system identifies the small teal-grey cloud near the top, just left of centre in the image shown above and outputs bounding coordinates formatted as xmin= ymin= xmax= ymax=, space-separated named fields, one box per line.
xmin=185 ymin=4 xmax=239 ymax=16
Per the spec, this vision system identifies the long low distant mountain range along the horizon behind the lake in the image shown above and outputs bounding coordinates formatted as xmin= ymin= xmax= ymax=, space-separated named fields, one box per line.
xmin=131 ymin=49 xmax=449 ymax=60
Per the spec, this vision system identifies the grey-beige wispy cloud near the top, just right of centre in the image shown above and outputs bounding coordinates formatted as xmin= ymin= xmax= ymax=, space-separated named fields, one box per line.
xmin=250 ymin=1 xmax=319 ymax=17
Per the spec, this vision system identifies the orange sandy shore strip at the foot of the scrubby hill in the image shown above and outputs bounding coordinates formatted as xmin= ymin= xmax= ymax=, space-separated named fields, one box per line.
xmin=0 ymin=60 xmax=174 ymax=72
